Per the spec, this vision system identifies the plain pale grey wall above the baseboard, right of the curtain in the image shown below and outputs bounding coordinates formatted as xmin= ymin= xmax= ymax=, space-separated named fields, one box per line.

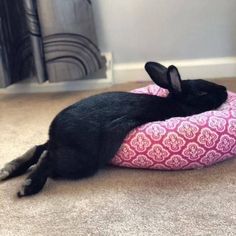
xmin=93 ymin=0 xmax=236 ymax=63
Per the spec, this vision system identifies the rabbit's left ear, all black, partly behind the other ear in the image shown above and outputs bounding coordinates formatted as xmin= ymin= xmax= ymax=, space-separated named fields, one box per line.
xmin=145 ymin=62 xmax=170 ymax=89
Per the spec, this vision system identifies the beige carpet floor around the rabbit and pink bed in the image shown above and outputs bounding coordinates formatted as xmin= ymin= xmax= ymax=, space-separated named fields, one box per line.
xmin=0 ymin=80 xmax=236 ymax=236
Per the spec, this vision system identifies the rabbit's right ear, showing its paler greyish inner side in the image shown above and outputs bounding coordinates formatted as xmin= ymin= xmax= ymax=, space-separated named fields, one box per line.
xmin=167 ymin=65 xmax=182 ymax=93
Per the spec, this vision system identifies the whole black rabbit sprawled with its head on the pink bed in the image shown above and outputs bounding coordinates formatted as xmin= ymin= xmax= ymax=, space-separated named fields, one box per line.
xmin=0 ymin=62 xmax=227 ymax=197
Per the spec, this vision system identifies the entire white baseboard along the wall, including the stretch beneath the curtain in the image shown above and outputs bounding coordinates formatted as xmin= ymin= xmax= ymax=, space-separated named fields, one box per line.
xmin=0 ymin=56 xmax=236 ymax=94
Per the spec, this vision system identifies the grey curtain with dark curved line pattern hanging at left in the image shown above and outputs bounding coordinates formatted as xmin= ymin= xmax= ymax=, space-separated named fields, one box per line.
xmin=0 ymin=0 xmax=105 ymax=87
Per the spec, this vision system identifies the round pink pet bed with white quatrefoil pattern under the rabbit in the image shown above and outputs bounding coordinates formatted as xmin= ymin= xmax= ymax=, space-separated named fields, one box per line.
xmin=111 ymin=85 xmax=236 ymax=170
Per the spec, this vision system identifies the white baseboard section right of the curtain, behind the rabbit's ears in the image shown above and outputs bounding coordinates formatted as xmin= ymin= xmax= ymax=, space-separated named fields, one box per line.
xmin=113 ymin=57 xmax=236 ymax=84
